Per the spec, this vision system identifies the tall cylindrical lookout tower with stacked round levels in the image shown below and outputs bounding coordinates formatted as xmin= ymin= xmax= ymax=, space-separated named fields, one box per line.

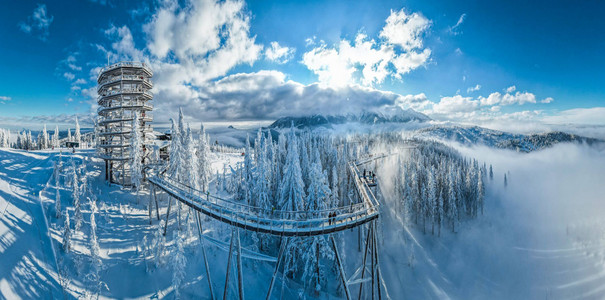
xmin=96 ymin=62 xmax=153 ymax=186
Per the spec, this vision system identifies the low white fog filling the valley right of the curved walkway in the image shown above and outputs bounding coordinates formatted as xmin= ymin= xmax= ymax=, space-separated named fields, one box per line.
xmin=378 ymin=144 xmax=605 ymax=299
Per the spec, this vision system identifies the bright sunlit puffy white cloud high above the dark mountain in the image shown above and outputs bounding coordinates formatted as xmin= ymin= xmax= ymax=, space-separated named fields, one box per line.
xmin=302 ymin=10 xmax=431 ymax=86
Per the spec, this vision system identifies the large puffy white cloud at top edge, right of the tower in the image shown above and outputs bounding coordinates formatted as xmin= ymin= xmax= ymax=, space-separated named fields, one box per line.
xmin=144 ymin=0 xmax=263 ymax=88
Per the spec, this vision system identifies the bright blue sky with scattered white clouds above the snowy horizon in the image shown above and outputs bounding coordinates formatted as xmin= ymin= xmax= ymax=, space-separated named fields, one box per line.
xmin=0 ymin=0 xmax=605 ymax=126
